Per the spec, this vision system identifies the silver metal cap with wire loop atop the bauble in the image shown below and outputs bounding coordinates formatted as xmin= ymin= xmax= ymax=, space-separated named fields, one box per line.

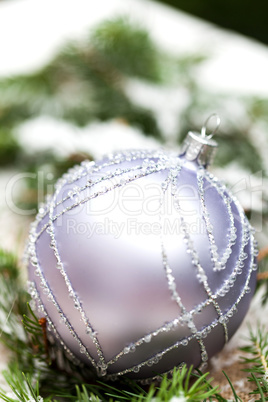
xmin=180 ymin=113 xmax=220 ymax=167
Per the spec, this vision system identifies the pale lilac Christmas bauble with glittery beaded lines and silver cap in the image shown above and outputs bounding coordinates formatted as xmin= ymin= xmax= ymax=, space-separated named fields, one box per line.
xmin=27 ymin=115 xmax=257 ymax=380
